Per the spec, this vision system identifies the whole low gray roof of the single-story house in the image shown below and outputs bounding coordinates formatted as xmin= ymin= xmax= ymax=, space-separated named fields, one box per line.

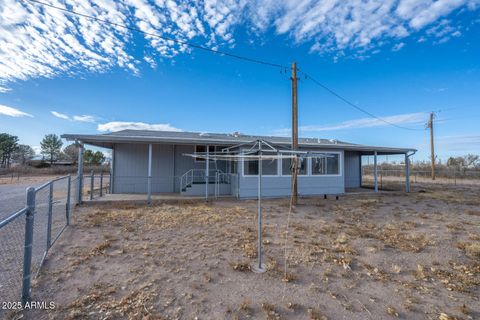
xmin=62 ymin=129 xmax=417 ymax=154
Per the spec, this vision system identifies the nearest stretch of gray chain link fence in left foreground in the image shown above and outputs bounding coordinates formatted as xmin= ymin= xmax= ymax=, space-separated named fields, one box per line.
xmin=0 ymin=176 xmax=78 ymax=312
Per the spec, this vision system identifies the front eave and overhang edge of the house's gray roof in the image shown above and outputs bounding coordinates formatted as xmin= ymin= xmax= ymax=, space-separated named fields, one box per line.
xmin=62 ymin=134 xmax=417 ymax=155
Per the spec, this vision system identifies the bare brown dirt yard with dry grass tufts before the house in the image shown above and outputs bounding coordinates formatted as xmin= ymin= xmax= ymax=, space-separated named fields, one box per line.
xmin=15 ymin=185 xmax=480 ymax=320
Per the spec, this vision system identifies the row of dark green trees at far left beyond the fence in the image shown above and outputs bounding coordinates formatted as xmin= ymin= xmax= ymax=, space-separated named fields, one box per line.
xmin=0 ymin=133 xmax=105 ymax=168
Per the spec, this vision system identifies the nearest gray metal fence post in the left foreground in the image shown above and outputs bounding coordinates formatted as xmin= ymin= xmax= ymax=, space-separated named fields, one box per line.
xmin=22 ymin=187 xmax=35 ymax=305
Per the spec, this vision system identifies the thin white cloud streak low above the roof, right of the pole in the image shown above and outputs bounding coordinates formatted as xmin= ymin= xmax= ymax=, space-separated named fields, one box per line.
xmin=275 ymin=112 xmax=428 ymax=135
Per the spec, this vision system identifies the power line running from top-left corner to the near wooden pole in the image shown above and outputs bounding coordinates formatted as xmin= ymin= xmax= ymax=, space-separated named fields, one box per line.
xmin=24 ymin=0 xmax=289 ymax=70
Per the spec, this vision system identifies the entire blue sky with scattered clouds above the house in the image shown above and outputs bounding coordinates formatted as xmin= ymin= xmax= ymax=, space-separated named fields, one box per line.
xmin=0 ymin=0 xmax=480 ymax=160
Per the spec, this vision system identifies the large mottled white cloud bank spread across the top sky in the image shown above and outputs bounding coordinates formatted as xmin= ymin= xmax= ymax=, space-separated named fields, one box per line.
xmin=0 ymin=0 xmax=480 ymax=92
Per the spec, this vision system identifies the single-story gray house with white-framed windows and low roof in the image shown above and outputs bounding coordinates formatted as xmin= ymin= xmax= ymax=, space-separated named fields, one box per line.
xmin=62 ymin=130 xmax=416 ymax=198
